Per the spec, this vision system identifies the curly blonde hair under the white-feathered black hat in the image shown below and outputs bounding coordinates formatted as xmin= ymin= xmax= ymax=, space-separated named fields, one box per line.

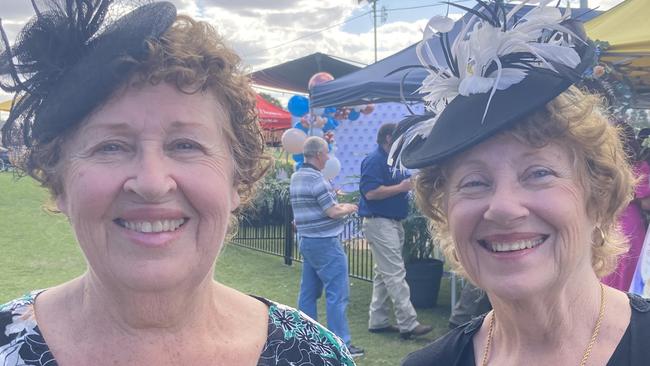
xmin=415 ymin=87 xmax=635 ymax=277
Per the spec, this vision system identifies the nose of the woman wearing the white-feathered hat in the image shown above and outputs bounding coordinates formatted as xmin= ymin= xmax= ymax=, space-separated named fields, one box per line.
xmin=483 ymin=185 xmax=529 ymax=225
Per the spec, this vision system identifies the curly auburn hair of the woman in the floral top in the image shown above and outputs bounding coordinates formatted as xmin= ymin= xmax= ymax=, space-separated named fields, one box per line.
xmin=21 ymin=15 xmax=271 ymax=213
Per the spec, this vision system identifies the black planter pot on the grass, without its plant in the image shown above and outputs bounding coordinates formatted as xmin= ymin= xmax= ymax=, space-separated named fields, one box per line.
xmin=405 ymin=259 xmax=443 ymax=308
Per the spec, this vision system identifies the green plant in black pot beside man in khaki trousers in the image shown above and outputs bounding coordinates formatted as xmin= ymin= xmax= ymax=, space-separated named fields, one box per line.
xmin=402 ymin=202 xmax=443 ymax=308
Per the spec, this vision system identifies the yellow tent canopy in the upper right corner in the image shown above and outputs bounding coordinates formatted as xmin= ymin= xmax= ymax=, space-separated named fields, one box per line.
xmin=585 ymin=0 xmax=650 ymax=108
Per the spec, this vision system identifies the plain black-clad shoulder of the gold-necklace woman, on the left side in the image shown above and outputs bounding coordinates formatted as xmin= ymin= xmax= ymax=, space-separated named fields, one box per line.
xmin=402 ymin=315 xmax=478 ymax=366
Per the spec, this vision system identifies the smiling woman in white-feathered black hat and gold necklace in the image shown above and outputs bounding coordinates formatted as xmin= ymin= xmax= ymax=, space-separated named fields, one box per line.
xmin=393 ymin=1 xmax=650 ymax=366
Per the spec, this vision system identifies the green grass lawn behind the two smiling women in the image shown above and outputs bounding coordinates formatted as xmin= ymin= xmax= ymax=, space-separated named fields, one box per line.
xmin=0 ymin=173 xmax=449 ymax=365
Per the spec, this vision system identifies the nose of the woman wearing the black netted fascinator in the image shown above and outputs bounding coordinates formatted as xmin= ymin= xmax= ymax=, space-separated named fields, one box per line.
xmin=124 ymin=151 xmax=177 ymax=202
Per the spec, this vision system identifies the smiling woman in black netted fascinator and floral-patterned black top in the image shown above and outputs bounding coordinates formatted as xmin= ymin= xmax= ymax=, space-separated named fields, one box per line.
xmin=0 ymin=0 xmax=354 ymax=365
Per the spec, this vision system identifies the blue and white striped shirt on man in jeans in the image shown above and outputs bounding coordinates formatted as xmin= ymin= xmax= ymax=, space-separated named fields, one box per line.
xmin=289 ymin=165 xmax=345 ymax=238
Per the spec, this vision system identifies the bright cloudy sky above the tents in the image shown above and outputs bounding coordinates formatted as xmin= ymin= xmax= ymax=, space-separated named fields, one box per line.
xmin=0 ymin=0 xmax=622 ymax=100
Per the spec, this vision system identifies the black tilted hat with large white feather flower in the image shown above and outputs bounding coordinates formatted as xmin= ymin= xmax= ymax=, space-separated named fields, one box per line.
xmin=389 ymin=0 xmax=595 ymax=168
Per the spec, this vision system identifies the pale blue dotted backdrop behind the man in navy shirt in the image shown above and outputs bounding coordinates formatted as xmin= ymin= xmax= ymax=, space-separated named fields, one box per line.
xmin=333 ymin=103 xmax=424 ymax=192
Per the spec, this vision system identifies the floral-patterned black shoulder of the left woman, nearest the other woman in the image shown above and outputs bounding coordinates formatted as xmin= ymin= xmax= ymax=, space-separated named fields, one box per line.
xmin=256 ymin=297 xmax=354 ymax=365
